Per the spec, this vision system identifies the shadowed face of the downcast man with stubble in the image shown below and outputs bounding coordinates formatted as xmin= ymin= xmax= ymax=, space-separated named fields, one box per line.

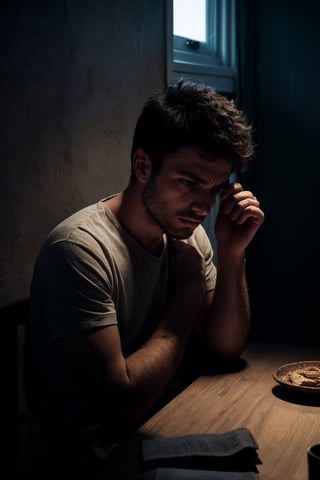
xmin=143 ymin=144 xmax=232 ymax=239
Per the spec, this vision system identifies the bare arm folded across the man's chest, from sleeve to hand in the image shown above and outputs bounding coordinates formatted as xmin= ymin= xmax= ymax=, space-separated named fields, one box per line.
xmin=59 ymin=242 xmax=205 ymax=421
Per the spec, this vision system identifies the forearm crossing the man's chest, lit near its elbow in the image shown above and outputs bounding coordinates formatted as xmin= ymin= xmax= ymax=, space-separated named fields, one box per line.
xmin=117 ymin=292 xmax=200 ymax=420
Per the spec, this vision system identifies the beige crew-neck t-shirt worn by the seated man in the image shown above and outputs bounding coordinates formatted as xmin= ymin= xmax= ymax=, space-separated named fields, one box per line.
xmin=31 ymin=200 xmax=216 ymax=448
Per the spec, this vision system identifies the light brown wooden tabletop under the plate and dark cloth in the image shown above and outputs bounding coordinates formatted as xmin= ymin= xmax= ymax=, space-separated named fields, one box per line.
xmin=109 ymin=343 xmax=320 ymax=480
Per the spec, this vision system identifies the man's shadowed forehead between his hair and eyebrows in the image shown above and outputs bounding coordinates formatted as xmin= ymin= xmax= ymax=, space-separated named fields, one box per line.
xmin=161 ymin=147 xmax=232 ymax=183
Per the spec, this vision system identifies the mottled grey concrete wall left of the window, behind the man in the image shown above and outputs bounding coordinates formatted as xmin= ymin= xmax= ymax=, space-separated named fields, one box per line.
xmin=0 ymin=0 xmax=166 ymax=305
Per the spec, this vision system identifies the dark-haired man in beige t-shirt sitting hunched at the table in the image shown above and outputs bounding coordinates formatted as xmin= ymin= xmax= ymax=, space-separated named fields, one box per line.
xmin=31 ymin=80 xmax=264 ymax=476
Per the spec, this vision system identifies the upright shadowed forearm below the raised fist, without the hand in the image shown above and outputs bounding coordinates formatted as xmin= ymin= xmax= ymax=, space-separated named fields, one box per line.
xmin=204 ymin=256 xmax=250 ymax=359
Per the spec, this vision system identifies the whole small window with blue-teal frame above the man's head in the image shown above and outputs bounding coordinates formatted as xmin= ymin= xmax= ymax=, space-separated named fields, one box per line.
xmin=168 ymin=0 xmax=236 ymax=94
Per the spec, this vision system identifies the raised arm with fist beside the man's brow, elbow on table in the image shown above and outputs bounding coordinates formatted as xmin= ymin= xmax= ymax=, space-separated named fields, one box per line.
xmin=205 ymin=183 xmax=264 ymax=359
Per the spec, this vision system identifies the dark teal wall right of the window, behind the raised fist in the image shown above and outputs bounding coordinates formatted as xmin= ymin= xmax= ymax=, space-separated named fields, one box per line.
xmin=248 ymin=0 xmax=320 ymax=346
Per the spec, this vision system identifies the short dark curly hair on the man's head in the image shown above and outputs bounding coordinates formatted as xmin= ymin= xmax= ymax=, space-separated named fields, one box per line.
xmin=131 ymin=78 xmax=254 ymax=181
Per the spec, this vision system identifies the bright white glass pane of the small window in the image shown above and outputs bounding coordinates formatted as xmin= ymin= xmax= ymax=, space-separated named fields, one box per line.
xmin=173 ymin=0 xmax=207 ymax=42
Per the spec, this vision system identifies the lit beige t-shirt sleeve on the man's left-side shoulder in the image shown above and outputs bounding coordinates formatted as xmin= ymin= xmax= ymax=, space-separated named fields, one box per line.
xmin=33 ymin=241 xmax=117 ymax=339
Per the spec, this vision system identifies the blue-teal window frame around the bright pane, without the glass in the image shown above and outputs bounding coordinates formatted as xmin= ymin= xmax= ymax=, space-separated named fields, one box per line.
xmin=167 ymin=0 xmax=237 ymax=93
